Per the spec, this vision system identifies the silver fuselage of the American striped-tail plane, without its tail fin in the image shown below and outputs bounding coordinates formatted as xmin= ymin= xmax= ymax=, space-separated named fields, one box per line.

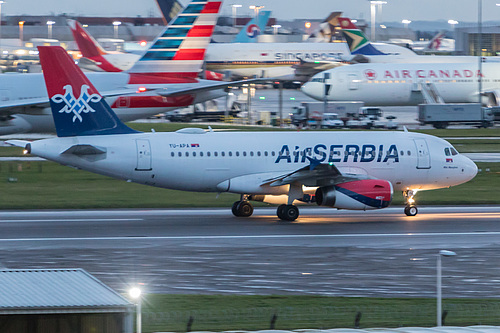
xmin=0 ymin=73 xmax=226 ymax=135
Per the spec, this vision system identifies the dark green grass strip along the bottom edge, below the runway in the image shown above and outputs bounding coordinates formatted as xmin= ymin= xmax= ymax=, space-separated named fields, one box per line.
xmin=143 ymin=302 xmax=500 ymax=332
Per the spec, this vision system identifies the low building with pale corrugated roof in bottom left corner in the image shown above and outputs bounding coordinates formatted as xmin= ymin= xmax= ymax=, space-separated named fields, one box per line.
xmin=0 ymin=269 xmax=134 ymax=333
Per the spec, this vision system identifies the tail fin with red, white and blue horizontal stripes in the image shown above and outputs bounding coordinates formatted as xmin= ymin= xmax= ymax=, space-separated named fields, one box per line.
xmin=128 ymin=0 xmax=222 ymax=84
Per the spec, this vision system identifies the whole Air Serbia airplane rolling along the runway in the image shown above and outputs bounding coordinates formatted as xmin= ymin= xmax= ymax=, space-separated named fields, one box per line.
xmin=7 ymin=46 xmax=477 ymax=221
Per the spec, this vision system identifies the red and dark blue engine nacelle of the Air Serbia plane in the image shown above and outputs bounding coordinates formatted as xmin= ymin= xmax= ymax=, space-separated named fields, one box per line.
xmin=316 ymin=179 xmax=393 ymax=210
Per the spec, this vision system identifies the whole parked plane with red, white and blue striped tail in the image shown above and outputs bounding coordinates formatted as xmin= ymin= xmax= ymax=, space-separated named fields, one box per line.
xmin=0 ymin=0 xmax=234 ymax=135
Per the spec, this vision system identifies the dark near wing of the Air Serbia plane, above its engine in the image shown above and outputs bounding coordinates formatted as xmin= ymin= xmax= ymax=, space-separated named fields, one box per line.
xmin=261 ymin=158 xmax=370 ymax=186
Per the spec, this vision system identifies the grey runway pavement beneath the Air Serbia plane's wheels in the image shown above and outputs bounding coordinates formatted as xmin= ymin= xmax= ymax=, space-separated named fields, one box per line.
xmin=0 ymin=207 xmax=500 ymax=298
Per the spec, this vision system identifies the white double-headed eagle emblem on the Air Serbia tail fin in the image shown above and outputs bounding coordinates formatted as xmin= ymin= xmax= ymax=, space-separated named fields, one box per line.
xmin=51 ymin=84 xmax=102 ymax=122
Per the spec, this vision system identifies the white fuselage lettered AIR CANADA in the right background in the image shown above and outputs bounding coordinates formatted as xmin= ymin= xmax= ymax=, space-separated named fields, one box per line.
xmin=302 ymin=63 xmax=500 ymax=105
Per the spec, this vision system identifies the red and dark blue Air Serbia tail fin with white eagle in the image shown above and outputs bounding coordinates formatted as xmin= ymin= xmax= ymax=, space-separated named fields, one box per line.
xmin=38 ymin=46 xmax=136 ymax=137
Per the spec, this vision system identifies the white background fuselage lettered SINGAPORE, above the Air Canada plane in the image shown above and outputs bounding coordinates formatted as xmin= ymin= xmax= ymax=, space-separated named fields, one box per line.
xmin=205 ymin=43 xmax=417 ymax=79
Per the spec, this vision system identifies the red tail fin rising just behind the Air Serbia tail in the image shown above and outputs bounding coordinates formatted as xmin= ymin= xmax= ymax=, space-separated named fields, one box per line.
xmin=66 ymin=20 xmax=122 ymax=72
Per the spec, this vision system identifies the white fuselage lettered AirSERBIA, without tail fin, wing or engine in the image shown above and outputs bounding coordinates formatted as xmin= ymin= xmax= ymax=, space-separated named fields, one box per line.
xmin=26 ymin=132 xmax=477 ymax=195
